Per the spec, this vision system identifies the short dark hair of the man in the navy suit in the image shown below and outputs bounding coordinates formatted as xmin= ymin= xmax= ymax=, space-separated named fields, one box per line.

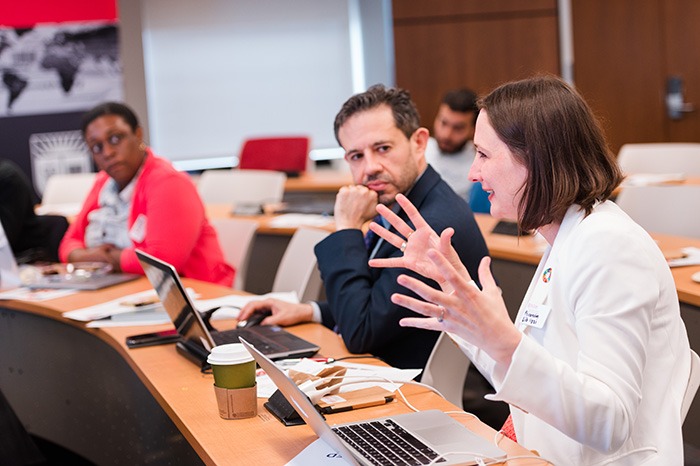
xmin=333 ymin=84 xmax=420 ymax=144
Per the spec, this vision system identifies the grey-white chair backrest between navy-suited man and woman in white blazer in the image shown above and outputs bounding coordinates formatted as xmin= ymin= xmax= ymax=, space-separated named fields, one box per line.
xmin=421 ymin=332 xmax=471 ymax=409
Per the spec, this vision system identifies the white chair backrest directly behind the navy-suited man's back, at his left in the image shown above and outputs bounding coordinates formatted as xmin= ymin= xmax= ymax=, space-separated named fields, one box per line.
xmin=272 ymin=227 xmax=330 ymax=302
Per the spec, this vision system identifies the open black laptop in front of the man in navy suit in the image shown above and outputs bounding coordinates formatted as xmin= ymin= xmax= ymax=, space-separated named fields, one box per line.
xmin=136 ymin=249 xmax=320 ymax=367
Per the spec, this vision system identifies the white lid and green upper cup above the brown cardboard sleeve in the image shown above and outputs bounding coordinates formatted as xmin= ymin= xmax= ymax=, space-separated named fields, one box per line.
xmin=207 ymin=343 xmax=255 ymax=389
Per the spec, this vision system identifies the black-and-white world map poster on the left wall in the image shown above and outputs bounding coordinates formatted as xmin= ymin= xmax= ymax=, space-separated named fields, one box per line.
xmin=0 ymin=21 xmax=124 ymax=118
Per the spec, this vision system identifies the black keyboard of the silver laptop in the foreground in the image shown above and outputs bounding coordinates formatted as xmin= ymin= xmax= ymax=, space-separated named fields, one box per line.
xmin=333 ymin=419 xmax=445 ymax=465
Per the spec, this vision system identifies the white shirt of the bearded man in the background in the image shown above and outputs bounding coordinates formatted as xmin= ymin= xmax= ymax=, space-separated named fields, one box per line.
xmin=425 ymin=137 xmax=476 ymax=202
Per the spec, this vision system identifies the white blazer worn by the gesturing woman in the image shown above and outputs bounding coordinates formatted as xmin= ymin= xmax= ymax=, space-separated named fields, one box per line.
xmin=456 ymin=201 xmax=690 ymax=466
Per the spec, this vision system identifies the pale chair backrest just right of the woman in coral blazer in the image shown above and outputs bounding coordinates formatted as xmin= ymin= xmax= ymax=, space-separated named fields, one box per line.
xmin=210 ymin=218 xmax=258 ymax=290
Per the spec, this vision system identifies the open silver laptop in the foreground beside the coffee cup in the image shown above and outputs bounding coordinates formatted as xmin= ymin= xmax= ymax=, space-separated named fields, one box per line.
xmin=241 ymin=339 xmax=506 ymax=465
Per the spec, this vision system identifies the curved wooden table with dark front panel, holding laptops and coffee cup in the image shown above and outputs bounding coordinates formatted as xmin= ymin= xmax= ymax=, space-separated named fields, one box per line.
xmin=0 ymin=278 xmax=544 ymax=465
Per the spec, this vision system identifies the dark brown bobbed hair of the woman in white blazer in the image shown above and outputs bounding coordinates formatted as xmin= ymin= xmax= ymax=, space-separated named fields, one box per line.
xmin=479 ymin=76 xmax=622 ymax=230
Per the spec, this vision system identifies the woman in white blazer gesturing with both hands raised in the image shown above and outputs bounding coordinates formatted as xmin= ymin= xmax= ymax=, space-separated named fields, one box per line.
xmin=370 ymin=77 xmax=690 ymax=466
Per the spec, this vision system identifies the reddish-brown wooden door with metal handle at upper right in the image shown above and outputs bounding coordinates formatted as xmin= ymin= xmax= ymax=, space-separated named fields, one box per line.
xmin=571 ymin=0 xmax=700 ymax=152
